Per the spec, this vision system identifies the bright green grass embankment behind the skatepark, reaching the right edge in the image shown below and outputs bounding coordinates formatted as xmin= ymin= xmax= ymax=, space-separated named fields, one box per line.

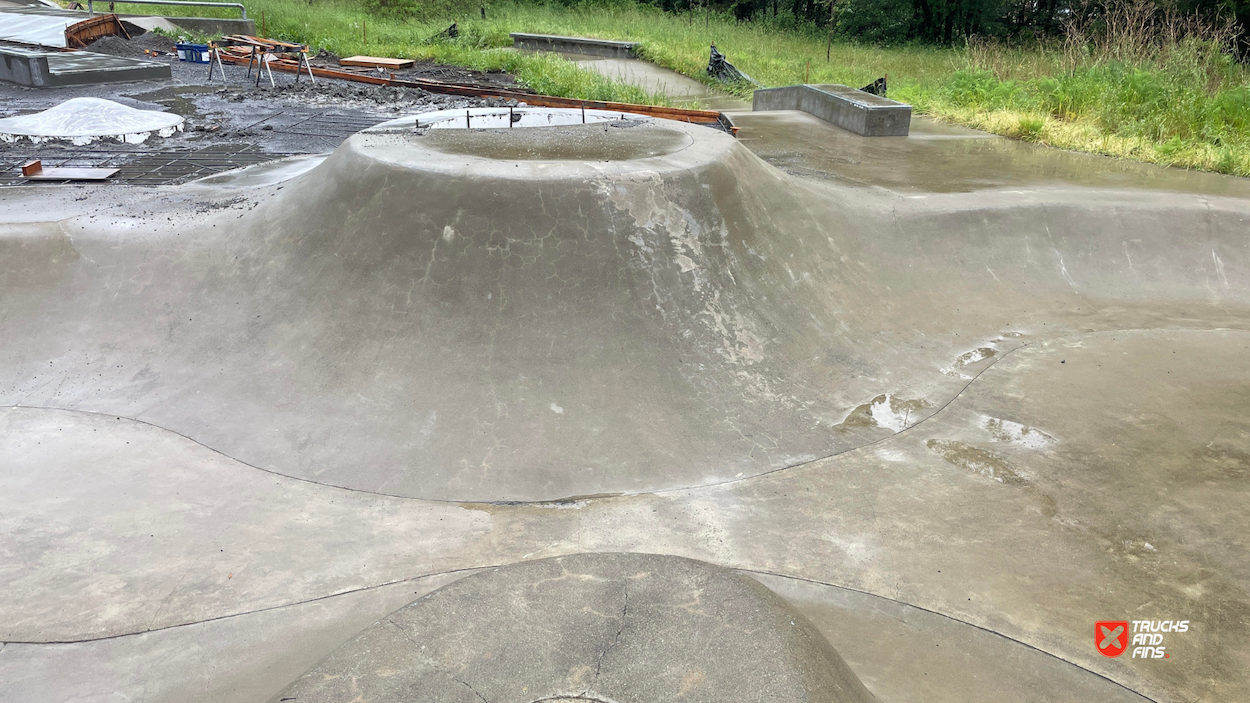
xmin=107 ymin=0 xmax=1250 ymax=175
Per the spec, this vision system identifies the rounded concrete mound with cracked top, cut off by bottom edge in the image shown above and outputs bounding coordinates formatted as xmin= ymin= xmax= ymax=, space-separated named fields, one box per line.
xmin=273 ymin=553 xmax=875 ymax=703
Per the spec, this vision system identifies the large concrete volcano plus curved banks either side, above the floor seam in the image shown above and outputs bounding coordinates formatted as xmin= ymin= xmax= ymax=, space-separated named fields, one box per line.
xmin=0 ymin=120 xmax=1250 ymax=500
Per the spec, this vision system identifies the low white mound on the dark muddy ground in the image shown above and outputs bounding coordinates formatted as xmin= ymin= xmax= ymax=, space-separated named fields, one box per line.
xmin=0 ymin=98 xmax=183 ymax=145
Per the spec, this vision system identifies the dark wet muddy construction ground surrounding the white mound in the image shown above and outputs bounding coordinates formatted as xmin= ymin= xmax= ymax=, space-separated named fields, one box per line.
xmin=0 ymin=34 xmax=527 ymax=185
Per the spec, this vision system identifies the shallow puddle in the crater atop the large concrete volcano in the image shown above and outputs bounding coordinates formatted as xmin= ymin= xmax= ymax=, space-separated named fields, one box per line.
xmin=411 ymin=124 xmax=694 ymax=161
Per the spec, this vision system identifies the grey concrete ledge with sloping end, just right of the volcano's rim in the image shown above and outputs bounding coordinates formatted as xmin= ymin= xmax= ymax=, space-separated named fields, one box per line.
xmin=751 ymin=84 xmax=911 ymax=136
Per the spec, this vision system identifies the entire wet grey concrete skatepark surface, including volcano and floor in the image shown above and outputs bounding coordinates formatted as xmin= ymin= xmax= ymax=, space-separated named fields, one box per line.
xmin=0 ymin=80 xmax=1250 ymax=703
